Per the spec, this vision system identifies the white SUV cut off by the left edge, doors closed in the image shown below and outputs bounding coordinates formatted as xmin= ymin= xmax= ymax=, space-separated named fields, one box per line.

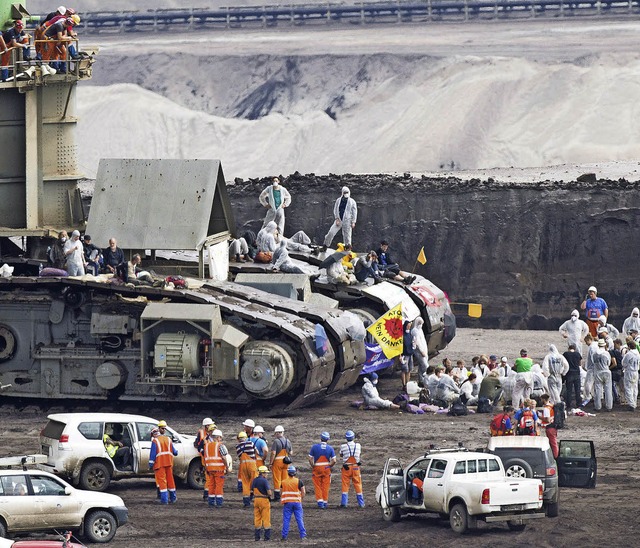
xmin=0 ymin=459 xmax=129 ymax=542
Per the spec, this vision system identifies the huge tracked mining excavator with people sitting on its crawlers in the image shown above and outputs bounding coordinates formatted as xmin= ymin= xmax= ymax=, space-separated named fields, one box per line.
xmin=0 ymin=0 xmax=452 ymax=408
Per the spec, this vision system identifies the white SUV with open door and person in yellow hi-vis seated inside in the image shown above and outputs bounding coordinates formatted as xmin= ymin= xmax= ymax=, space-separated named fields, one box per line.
xmin=38 ymin=413 xmax=204 ymax=491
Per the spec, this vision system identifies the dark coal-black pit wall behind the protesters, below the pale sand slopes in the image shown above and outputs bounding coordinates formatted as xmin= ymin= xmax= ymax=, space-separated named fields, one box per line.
xmin=230 ymin=175 xmax=640 ymax=329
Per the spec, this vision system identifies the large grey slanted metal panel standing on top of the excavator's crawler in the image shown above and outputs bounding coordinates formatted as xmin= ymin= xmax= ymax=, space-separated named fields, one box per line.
xmin=87 ymin=159 xmax=234 ymax=250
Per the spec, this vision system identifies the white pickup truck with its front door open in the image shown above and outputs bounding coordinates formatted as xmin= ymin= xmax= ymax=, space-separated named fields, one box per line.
xmin=376 ymin=449 xmax=545 ymax=534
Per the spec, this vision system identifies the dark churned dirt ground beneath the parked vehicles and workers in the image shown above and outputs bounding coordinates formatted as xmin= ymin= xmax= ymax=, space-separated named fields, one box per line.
xmin=0 ymin=329 xmax=640 ymax=548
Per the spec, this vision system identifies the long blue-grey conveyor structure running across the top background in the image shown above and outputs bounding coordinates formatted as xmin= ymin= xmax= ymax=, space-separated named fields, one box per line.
xmin=63 ymin=0 xmax=640 ymax=32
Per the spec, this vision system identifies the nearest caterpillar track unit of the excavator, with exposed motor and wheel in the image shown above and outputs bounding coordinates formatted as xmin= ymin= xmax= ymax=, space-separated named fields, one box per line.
xmin=0 ymin=276 xmax=365 ymax=409
